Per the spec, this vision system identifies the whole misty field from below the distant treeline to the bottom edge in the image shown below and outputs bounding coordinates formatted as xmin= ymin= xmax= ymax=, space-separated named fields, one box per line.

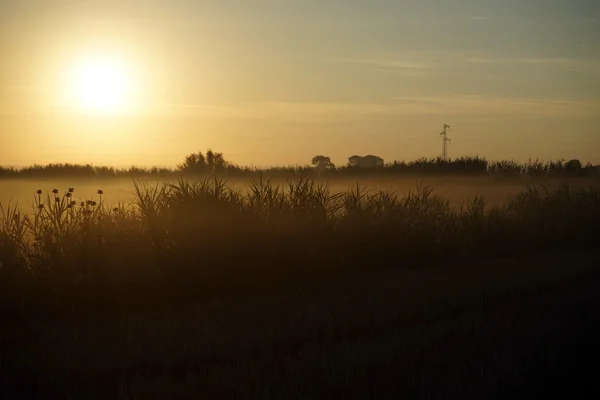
xmin=0 ymin=176 xmax=600 ymax=399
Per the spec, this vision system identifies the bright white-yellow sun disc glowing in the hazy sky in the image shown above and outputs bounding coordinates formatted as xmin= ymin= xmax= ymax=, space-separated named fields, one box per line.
xmin=67 ymin=58 xmax=136 ymax=114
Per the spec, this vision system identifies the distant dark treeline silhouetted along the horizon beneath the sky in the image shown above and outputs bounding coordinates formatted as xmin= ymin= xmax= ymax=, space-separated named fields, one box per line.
xmin=0 ymin=149 xmax=600 ymax=178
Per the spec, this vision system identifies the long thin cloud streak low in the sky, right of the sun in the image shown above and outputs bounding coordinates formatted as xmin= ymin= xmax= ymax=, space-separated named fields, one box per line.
xmin=155 ymin=95 xmax=600 ymax=123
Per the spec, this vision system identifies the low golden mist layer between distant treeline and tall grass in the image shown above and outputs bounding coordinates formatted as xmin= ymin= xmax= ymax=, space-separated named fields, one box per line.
xmin=0 ymin=174 xmax=599 ymax=207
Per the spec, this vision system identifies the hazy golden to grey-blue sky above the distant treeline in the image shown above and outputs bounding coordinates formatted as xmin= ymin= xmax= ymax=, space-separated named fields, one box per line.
xmin=0 ymin=0 xmax=600 ymax=166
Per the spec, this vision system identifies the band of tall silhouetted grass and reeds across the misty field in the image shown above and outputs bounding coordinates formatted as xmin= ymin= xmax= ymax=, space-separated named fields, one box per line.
xmin=0 ymin=175 xmax=600 ymax=314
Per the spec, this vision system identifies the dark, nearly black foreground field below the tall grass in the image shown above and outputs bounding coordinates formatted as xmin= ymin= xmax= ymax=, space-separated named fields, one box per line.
xmin=0 ymin=251 xmax=600 ymax=399
